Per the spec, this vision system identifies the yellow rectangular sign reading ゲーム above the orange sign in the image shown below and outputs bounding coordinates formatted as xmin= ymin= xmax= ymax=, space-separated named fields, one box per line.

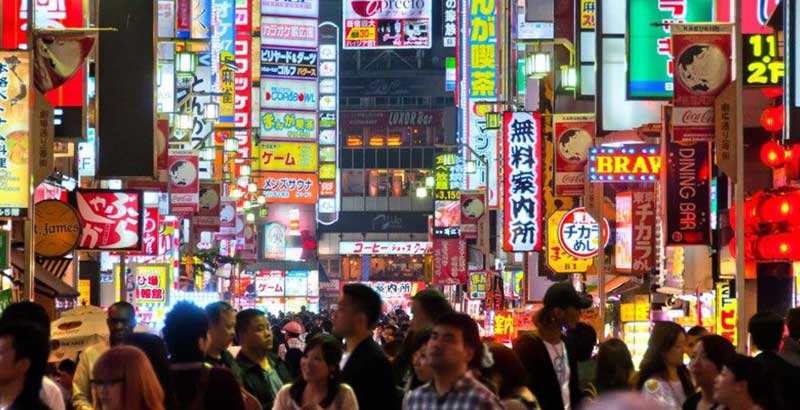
xmin=253 ymin=141 xmax=317 ymax=172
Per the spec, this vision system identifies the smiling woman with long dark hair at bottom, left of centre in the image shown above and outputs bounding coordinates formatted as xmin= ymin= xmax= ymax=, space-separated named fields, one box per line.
xmin=272 ymin=335 xmax=358 ymax=410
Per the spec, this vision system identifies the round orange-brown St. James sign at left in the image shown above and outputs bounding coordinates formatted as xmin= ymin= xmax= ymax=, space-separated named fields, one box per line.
xmin=34 ymin=199 xmax=81 ymax=258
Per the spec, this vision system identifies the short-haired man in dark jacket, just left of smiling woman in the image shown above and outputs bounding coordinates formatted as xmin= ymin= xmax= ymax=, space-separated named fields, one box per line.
xmin=236 ymin=309 xmax=291 ymax=409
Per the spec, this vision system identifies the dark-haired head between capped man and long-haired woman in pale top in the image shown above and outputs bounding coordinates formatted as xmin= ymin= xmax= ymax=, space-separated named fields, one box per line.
xmin=594 ymin=339 xmax=634 ymax=393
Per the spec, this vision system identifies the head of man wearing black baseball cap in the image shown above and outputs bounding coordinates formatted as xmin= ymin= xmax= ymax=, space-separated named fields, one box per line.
xmin=536 ymin=281 xmax=592 ymax=328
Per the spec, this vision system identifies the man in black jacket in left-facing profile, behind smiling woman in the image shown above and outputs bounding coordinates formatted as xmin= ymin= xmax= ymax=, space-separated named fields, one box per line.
xmin=333 ymin=283 xmax=400 ymax=410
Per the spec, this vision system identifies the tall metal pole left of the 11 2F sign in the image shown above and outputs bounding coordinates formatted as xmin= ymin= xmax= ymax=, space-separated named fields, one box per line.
xmin=733 ymin=0 xmax=748 ymax=353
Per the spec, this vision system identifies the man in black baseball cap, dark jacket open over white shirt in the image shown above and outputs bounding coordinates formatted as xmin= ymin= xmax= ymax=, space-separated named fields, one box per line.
xmin=514 ymin=281 xmax=592 ymax=410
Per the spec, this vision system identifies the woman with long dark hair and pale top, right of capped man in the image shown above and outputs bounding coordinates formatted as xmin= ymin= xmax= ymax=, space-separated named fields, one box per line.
xmin=637 ymin=322 xmax=694 ymax=409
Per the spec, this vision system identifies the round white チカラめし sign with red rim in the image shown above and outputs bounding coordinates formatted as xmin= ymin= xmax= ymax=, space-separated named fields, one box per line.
xmin=558 ymin=207 xmax=610 ymax=258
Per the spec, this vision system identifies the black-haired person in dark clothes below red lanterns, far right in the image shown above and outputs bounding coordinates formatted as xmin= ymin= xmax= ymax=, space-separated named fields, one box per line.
xmin=747 ymin=312 xmax=800 ymax=410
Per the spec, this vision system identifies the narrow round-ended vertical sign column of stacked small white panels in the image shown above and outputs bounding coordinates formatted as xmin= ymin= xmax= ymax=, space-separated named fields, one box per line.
xmin=317 ymin=22 xmax=341 ymax=225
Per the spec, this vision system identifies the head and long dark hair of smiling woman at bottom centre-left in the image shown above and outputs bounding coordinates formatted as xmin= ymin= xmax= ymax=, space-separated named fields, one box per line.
xmin=289 ymin=335 xmax=343 ymax=407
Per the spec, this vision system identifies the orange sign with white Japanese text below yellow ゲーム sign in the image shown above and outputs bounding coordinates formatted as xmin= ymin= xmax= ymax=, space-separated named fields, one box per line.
xmin=254 ymin=172 xmax=319 ymax=204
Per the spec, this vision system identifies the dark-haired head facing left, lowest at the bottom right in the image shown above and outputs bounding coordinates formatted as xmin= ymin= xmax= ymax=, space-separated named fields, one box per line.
xmin=714 ymin=354 xmax=770 ymax=408
